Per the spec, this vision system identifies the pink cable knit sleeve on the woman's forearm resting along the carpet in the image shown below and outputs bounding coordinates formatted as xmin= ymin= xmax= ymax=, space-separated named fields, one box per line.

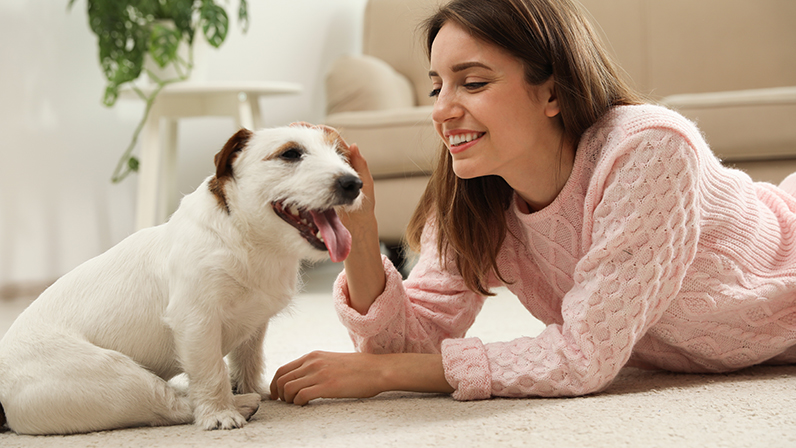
xmin=443 ymin=122 xmax=699 ymax=400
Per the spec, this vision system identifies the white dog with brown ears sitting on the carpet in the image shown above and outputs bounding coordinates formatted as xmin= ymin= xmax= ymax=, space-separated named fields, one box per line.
xmin=0 ymin=125 xmax=362 ymax=434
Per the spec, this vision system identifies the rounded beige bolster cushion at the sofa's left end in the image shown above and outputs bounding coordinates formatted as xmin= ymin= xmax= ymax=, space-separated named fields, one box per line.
xmin=326 ymin=55 xmax=415 ymax=114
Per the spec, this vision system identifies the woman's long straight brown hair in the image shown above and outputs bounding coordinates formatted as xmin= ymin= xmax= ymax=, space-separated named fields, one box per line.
xmin=407 ymin=0 xmax=643 ymax=295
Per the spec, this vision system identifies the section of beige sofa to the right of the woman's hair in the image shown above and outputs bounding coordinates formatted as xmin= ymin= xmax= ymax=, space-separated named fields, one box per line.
xmin=581 ymin=0 xmax=796 ymax=183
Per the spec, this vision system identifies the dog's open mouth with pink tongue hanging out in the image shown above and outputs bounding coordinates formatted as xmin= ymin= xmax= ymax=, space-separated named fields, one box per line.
xmin=271 ymin=201 xmax=351 ymax=263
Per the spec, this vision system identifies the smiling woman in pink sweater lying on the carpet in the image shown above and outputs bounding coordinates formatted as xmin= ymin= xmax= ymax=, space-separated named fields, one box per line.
xmin=271 ymin=0 xmax=796 ymax=404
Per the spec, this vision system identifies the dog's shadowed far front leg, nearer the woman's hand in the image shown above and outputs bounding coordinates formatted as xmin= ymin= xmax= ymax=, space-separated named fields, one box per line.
xmin=228 ymin=323 xmax=271 ymax=400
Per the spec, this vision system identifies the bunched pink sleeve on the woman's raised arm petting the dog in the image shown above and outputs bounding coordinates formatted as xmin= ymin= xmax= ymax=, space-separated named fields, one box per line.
xmin=333 ymin=224 xmax=484 ymax=353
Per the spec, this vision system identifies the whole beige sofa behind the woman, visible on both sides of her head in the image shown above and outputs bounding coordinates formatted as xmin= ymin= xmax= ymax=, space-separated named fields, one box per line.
xmin=325 ymin=0 xmax=796 ymax=245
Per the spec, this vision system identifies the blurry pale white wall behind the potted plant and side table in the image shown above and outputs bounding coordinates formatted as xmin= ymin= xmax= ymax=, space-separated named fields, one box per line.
xmin=0 ymin=0 xmax=365 ymax=299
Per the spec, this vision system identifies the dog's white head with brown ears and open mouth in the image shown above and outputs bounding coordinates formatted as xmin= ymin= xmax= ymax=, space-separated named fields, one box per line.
xmin=208 ymin=124 xmax=362 ymax=262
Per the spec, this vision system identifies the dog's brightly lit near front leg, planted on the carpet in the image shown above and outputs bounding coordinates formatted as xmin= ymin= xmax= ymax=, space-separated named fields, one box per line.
xmin=167 ymin=306 xmax=261 ymax=429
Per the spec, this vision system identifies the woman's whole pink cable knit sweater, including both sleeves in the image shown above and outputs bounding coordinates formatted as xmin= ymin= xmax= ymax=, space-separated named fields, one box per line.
xmin=335 ymin=106 xmax=796 ymax=400
